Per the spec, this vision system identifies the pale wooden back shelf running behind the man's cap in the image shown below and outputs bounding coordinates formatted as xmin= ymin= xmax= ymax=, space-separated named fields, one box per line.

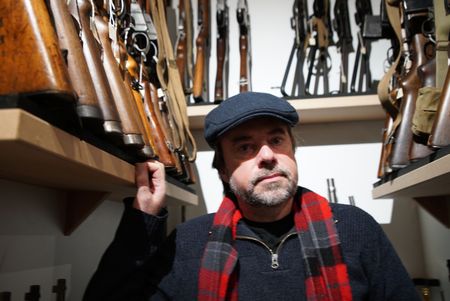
xmin=188 ymin=94 xmax=386 ymax=130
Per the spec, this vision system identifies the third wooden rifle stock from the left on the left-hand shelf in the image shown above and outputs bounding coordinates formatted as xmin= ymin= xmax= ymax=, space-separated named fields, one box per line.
xmin=73 ymin=0 xmax=122 ymax=138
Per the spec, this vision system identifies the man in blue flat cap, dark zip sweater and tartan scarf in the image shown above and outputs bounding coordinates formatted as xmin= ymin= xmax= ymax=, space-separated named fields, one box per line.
xmin=85 ymin=92 xmax=420 ymax=301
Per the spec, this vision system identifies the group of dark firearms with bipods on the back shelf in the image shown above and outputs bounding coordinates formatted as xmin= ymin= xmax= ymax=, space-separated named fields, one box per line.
xmin=281 ymin=0 xmax=384 ymax=98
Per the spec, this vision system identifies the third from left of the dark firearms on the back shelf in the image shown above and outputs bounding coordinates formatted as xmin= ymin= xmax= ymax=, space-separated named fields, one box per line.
xmin=333 ymin=0 xmax=354 ymax=93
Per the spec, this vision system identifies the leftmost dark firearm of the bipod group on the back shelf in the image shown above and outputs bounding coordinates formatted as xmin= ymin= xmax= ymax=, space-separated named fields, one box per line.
xmin=281 ymin=0 xmax=308 ymax=97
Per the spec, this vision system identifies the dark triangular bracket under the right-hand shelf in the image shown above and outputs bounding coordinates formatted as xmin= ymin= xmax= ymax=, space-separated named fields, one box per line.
xmin=414 ymin=195 xmax=450 ymax=228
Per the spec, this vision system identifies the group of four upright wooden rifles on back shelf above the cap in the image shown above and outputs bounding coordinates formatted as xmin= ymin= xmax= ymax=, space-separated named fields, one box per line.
xmin=176 ymin=0 xmax=251 ymax=103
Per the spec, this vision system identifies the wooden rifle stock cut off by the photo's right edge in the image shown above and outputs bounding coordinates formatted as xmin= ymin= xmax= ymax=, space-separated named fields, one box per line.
xmin=428 ymin=69 xmax=450 ymax=148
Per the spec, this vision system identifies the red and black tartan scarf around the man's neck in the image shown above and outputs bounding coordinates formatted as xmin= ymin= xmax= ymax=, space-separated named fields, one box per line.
xmin=198 ymin=187 xmax=352 ymax=301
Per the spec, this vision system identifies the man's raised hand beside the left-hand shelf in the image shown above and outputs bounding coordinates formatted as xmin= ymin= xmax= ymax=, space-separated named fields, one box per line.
xmin=133 ymin=161 xmax=166 ymax=215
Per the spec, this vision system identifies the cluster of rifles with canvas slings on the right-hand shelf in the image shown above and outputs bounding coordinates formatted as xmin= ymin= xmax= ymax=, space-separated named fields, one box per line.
xmin=378 ymin=0 xmax=450 ymax=178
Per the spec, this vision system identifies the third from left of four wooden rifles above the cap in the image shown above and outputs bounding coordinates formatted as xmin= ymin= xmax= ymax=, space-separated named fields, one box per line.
xmin=214 ymin=0 xmax=229 ymax=103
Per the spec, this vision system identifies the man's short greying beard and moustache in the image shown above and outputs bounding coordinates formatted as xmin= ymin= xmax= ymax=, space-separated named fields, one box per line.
xmin=229 ymin=167 xmax=297 ymax=207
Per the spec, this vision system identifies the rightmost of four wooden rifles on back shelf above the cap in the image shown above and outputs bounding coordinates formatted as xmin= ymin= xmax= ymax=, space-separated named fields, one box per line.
xmin=236 ymin=0 xmax=252 ymax=92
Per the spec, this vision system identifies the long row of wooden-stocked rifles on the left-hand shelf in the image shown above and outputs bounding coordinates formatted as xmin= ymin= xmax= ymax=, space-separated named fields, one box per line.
xmin=0 ymin=0 xmax=196 ymax=183
